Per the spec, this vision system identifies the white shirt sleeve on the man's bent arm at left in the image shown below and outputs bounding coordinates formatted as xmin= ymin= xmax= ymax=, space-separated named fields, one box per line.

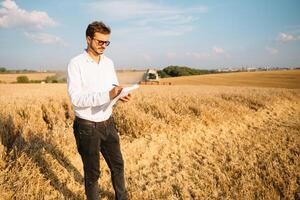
xmin=67 ymin=60 xmax=110 ymax=107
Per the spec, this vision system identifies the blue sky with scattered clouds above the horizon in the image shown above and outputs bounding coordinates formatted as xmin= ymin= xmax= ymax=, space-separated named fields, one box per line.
xmin=0 ymin=0 xmax=300 ymax=70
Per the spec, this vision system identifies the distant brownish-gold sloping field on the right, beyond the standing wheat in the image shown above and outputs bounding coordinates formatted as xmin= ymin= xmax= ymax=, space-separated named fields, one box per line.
xmin=161 ymin=70 xmax=300 ymax=89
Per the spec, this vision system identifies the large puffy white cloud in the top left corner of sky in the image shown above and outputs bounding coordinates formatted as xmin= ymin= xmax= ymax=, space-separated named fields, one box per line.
xmin=0 ymin=0 xmax=56 ymax=29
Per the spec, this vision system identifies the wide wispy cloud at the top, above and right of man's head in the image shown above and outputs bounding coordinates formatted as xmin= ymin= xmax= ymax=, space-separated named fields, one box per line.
xmin=88 ymin=0 xmax=208 ymax=36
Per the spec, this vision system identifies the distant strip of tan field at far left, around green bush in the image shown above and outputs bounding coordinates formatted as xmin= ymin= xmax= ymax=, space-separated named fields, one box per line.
xmin=0 ymin=73 xmax=55 ymax=83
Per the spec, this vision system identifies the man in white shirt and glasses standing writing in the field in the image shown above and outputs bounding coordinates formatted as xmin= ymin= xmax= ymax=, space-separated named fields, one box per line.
xmin=68 ymin=22 xmax=130 ymax=200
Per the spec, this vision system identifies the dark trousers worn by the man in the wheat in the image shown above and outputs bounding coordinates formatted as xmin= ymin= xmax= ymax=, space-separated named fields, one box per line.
xmin=73 ymin=117 xmax=128 ymax=200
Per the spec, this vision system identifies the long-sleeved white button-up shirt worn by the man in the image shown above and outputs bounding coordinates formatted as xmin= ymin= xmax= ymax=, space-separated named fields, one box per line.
xmin=67 ymin=51 xmax=119 ymax=122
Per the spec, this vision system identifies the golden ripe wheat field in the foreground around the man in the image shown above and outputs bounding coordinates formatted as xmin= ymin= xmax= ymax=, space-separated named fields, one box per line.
xmin=0 ymin=74 xmax=300 ymax=200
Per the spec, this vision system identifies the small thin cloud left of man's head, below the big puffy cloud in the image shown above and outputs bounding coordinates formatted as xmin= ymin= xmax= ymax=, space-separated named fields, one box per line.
xmin=25 ymin=32 xmax=67 ymax=46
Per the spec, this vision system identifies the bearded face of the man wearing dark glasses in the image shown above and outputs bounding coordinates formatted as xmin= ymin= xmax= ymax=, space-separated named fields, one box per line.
xmin=87 ymin=32 xmax=109 ymax=55
